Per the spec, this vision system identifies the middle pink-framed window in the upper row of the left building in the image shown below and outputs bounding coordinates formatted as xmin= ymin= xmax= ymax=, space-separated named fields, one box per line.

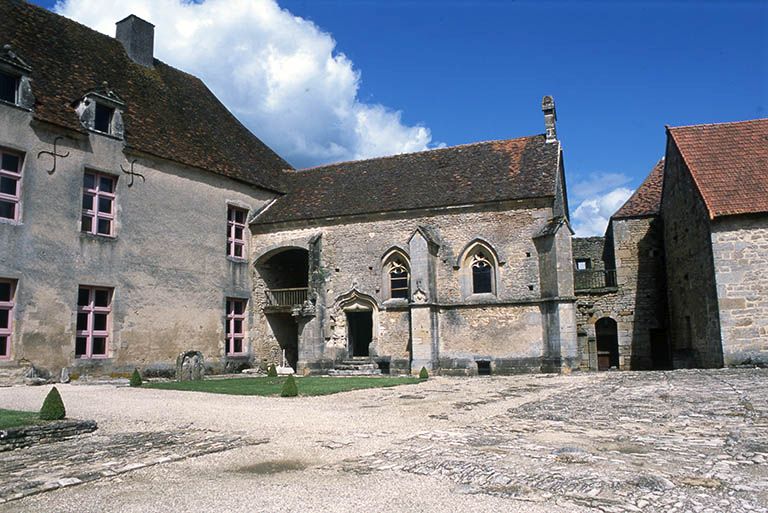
xmin=80 ymin=171 xmax=117 ymax=237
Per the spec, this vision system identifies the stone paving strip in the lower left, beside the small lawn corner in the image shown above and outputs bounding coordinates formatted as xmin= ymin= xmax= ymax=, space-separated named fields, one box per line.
xmin=0 ymin=430 xmax=267 ymax=503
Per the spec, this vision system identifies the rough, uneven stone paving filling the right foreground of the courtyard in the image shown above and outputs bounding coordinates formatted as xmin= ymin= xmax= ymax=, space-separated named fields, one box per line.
xmin=336 ymin=370 xmax=768 ymax=513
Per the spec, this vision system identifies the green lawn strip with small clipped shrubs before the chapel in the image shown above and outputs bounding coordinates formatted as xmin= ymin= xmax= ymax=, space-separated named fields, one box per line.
xmin=142 ymin=376 xmax=422 ymax=395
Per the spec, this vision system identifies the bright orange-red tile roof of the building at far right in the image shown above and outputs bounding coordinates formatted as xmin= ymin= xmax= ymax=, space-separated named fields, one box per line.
xmin=668 ymin=119 xmax=768 ymax=219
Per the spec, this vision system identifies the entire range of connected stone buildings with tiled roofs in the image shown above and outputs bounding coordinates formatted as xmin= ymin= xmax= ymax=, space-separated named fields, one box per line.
xmin=0 ymin=0 xmax=768 ymax=377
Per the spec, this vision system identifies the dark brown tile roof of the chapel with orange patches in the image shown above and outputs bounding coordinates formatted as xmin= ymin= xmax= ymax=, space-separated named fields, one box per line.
xmin=255 ymin=135 xmax=560 ymax=224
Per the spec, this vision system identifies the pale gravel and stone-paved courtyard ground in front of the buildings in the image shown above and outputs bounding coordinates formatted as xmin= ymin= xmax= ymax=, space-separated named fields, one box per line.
xmin=0 ymin=369 xmax=768 ymax=513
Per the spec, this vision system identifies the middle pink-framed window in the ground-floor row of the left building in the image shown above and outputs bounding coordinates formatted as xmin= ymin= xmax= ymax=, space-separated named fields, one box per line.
xmin=75 ymin=287 xmax=112 ymax=358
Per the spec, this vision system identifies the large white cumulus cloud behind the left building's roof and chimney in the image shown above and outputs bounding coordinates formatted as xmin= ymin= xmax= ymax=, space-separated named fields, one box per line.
xmin=55 ymin=0 xmax=431 ymax=167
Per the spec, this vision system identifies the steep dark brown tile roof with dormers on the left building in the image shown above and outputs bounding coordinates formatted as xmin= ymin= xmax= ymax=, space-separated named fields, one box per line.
xmin=0 ymin=0 xmax=290 ymax=190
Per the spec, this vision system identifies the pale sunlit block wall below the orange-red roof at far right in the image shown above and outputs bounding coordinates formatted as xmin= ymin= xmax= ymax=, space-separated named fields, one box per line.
xmin=712 ymin=216 xmax=768 ymax=365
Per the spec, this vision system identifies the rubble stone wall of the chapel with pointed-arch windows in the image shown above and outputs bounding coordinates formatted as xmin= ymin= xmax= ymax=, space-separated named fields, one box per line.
xmin=252 ymin=201 xmax=570 ymax=374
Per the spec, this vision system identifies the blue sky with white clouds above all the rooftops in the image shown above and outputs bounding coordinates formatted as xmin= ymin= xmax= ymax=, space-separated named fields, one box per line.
xmin=28 ymin=0 xmax=768 ymax=234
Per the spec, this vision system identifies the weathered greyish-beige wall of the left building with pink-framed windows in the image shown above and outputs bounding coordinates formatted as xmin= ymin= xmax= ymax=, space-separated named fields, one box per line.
xmin=0 ymin=105 xmax=273 ymax=375
